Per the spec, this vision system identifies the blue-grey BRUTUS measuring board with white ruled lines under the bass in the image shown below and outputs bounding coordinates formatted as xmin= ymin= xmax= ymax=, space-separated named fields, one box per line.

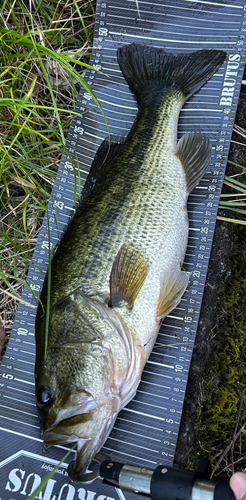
xmin=0 ymin=0 xmax=246 ymax=500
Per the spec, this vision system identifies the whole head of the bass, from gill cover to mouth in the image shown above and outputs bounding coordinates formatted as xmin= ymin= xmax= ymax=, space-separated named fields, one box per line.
xmin=36 ymin=296 xmax=133 ymax=474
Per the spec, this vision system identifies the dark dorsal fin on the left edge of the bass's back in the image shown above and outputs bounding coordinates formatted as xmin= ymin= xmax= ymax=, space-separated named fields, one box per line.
xmin=82 ymin=136 xmax=125 ymax=198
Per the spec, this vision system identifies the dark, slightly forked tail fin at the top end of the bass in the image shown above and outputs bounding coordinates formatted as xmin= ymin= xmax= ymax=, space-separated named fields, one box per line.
xmin=117 ymin=43 xmax=226 ymax=100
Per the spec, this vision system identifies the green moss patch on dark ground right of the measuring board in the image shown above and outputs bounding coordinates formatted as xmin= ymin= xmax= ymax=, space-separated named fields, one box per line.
xmin=196 ymin=228 xmax=246 ymax=472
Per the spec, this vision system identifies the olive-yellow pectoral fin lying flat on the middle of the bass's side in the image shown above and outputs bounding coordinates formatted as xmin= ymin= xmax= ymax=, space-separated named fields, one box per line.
xmin=109 ymin=245 xmax=148 ymax=309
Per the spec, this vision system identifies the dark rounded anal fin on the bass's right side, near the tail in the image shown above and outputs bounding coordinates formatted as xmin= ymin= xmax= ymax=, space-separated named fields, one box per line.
xmin=175 ymin=132 xmax=212 ymax=193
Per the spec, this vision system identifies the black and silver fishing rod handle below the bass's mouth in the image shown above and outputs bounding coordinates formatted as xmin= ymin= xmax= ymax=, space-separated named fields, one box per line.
xmin=100 ymin=460 xmax=236 ymax=500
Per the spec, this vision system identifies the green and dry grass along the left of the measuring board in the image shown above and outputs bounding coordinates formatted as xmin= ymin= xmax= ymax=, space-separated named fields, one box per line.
xmin=0 ymin=0 xmax=96 ymax=331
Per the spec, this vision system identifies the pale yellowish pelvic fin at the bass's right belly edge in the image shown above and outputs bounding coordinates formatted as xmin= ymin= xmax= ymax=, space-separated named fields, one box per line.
xmin=157 ymin=269 xmax=189 ymax=320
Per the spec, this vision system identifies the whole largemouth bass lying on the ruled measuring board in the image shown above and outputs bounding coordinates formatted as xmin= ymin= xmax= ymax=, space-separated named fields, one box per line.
xmin=35 ymin=44 xmax=226 ymax=477
